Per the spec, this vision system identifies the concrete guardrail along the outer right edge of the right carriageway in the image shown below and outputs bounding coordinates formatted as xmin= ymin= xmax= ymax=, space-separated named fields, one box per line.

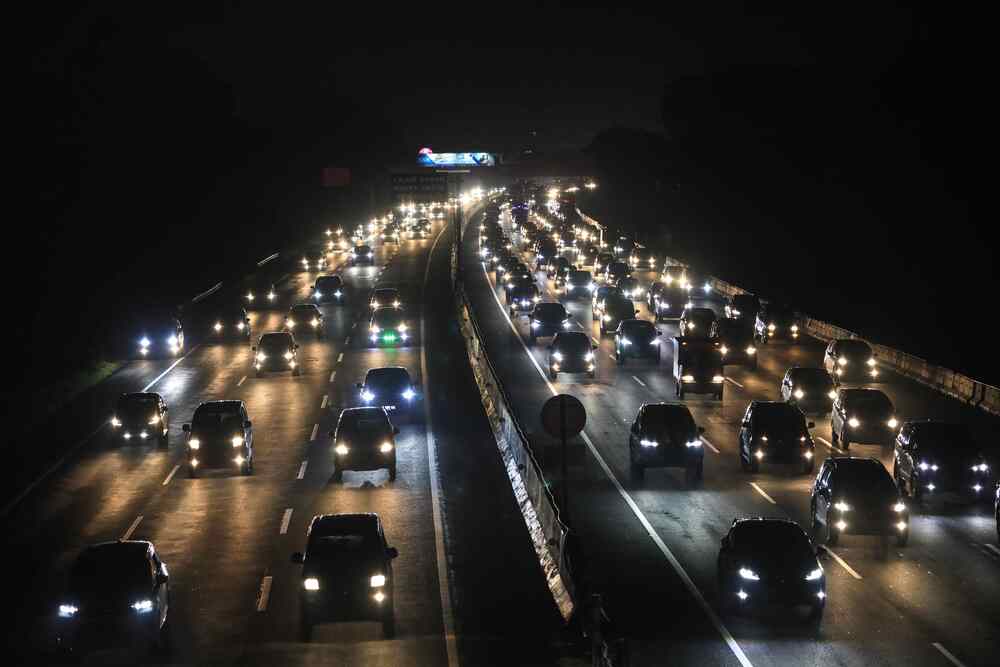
xmin=577 ymin=209 xmax=1000 ymax=415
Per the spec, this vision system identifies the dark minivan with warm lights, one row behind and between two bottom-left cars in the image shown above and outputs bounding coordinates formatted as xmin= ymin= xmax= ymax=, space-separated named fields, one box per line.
xmin=183 ymin=400 xmax=254 ymax=477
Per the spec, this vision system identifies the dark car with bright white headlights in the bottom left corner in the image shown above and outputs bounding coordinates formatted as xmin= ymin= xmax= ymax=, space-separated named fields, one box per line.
xmin=56 ymin=540 xmax=170 ymax=654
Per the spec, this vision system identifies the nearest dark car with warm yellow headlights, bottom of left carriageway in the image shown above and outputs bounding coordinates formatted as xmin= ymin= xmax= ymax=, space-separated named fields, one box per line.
xmin=292 ymin=514 xmax=399 ymax=641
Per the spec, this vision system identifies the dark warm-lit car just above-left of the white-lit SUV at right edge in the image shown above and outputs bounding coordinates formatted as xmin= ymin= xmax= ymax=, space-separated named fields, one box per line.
xmin=830 ymin=388 xmax=899 ymax=451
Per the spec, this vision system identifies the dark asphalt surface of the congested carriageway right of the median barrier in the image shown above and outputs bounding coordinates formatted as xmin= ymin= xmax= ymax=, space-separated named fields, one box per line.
xmin=462 ymin=205 xmax=1000 ymax=667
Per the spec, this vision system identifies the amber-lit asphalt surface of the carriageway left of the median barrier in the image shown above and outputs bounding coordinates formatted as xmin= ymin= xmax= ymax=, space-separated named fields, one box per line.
xmin=2 ymin=217 xmax=561 ymax=666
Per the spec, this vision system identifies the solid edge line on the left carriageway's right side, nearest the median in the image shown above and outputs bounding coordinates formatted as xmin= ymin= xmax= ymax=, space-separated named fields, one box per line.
xmin=420 ymin=214 xmax=460 ymax=667
